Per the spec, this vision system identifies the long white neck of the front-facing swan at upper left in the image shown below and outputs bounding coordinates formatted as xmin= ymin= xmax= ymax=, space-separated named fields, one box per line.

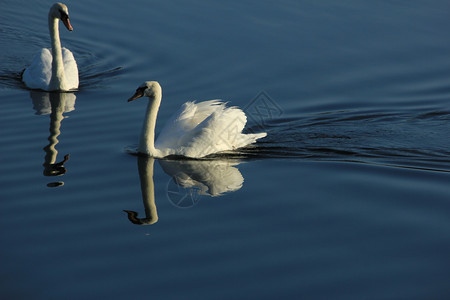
xmin=48 ymin=14 xmax=67 ymax=91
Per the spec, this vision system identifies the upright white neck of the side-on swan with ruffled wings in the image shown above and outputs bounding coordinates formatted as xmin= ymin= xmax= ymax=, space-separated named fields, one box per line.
xmin=138 ymin=95 xmax=161 ymax=157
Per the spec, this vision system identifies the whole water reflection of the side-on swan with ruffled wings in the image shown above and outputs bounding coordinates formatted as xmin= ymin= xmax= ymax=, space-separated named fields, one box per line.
xmin=124 ymin=156 xmax=244 ymax=225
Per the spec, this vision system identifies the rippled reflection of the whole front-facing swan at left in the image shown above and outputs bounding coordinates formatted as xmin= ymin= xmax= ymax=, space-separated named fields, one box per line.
xmin=30 ymin=91 xmax=76 ymax=187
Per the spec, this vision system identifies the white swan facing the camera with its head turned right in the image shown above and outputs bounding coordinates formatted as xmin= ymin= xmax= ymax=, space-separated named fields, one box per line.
xmin=22 ymin=3 xmax=78 ymax=91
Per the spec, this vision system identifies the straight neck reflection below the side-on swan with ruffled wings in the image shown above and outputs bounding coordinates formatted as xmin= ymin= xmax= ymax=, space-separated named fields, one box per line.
xmin=138 ymin=157 xmax=158 ymax=225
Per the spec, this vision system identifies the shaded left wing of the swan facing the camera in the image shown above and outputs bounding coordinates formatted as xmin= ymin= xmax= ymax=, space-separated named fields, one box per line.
xmin=22 ymin=48 xmax=52 ymax=90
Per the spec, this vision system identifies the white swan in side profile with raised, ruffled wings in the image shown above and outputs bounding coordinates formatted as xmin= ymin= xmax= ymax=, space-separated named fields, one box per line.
xmin=128 ymin=81 xmax=267 ymax=158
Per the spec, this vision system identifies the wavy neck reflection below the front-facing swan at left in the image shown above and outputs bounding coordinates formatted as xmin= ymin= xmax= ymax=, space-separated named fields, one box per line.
xmin=44 ymin=93 xmax=65 ymax=166
